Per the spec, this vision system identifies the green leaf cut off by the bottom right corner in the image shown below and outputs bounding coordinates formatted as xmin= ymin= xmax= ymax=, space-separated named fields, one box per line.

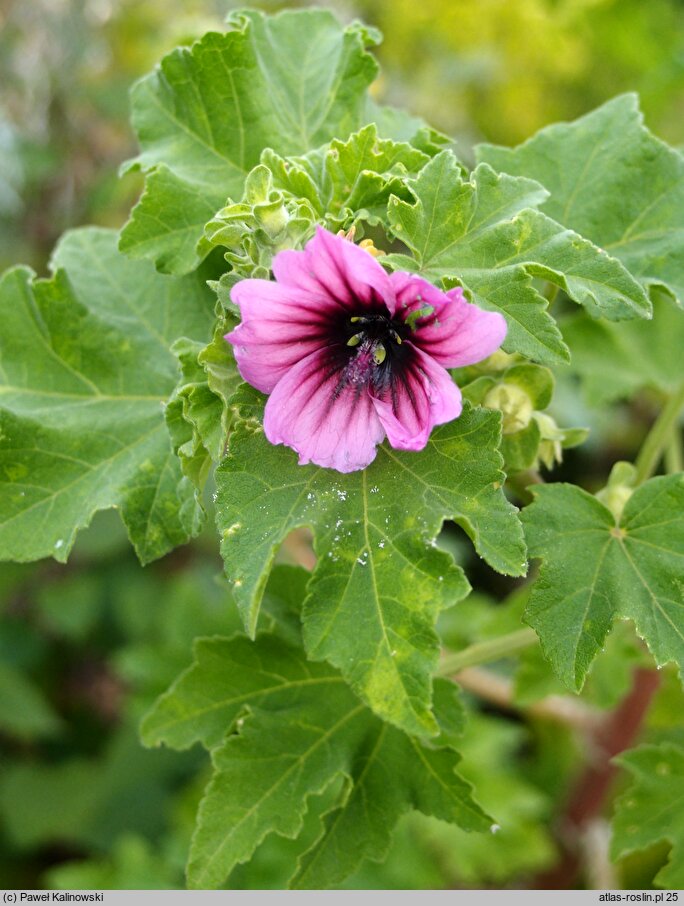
xmin=611 ymin=742 xmax=684 ymax=890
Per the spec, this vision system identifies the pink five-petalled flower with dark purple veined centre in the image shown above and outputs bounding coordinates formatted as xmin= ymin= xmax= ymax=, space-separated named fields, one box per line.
xmin=226 ymin=227 xmax=506 ymax=472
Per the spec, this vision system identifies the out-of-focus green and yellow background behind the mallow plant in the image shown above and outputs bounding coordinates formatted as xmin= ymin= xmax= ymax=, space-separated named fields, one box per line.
xmin=0 ymin=0 xmax=684 ymax=888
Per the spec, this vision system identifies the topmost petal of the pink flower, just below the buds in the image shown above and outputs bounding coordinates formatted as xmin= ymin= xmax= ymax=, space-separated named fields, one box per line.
xmin=272 ymin=227 xmax=394 ymax=314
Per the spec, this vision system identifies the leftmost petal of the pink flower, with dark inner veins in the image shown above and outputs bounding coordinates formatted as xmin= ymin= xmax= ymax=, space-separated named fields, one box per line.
xmin=225 ymin=280 xmax=337 ymax=393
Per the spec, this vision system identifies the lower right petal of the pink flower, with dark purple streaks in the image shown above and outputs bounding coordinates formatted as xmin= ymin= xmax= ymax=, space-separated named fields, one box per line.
xmin=373 ymin=347 xmax=462 ymax=450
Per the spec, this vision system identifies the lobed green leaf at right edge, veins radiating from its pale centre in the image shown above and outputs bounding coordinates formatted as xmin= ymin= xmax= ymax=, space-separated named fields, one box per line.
xmin=522 ymin=474 xmax=684 ymax=690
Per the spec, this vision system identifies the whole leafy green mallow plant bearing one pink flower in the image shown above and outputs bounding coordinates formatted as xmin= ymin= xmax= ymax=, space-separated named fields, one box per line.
xmin=0 ymin=9 xmax=684 ymax=888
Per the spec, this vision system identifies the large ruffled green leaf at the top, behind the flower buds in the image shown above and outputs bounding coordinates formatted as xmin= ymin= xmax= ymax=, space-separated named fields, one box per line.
xmin=120 ymin=10 xmax=377 ymax=274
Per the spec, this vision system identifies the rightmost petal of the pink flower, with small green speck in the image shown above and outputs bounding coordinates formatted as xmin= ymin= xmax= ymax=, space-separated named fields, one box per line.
xmin=391 ymin=271 xmax=507 ymax=368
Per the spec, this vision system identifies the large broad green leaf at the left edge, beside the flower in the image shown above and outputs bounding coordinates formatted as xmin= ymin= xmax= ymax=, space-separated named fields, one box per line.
xmin=0 ymin=229 xmax=212 ymax=562
